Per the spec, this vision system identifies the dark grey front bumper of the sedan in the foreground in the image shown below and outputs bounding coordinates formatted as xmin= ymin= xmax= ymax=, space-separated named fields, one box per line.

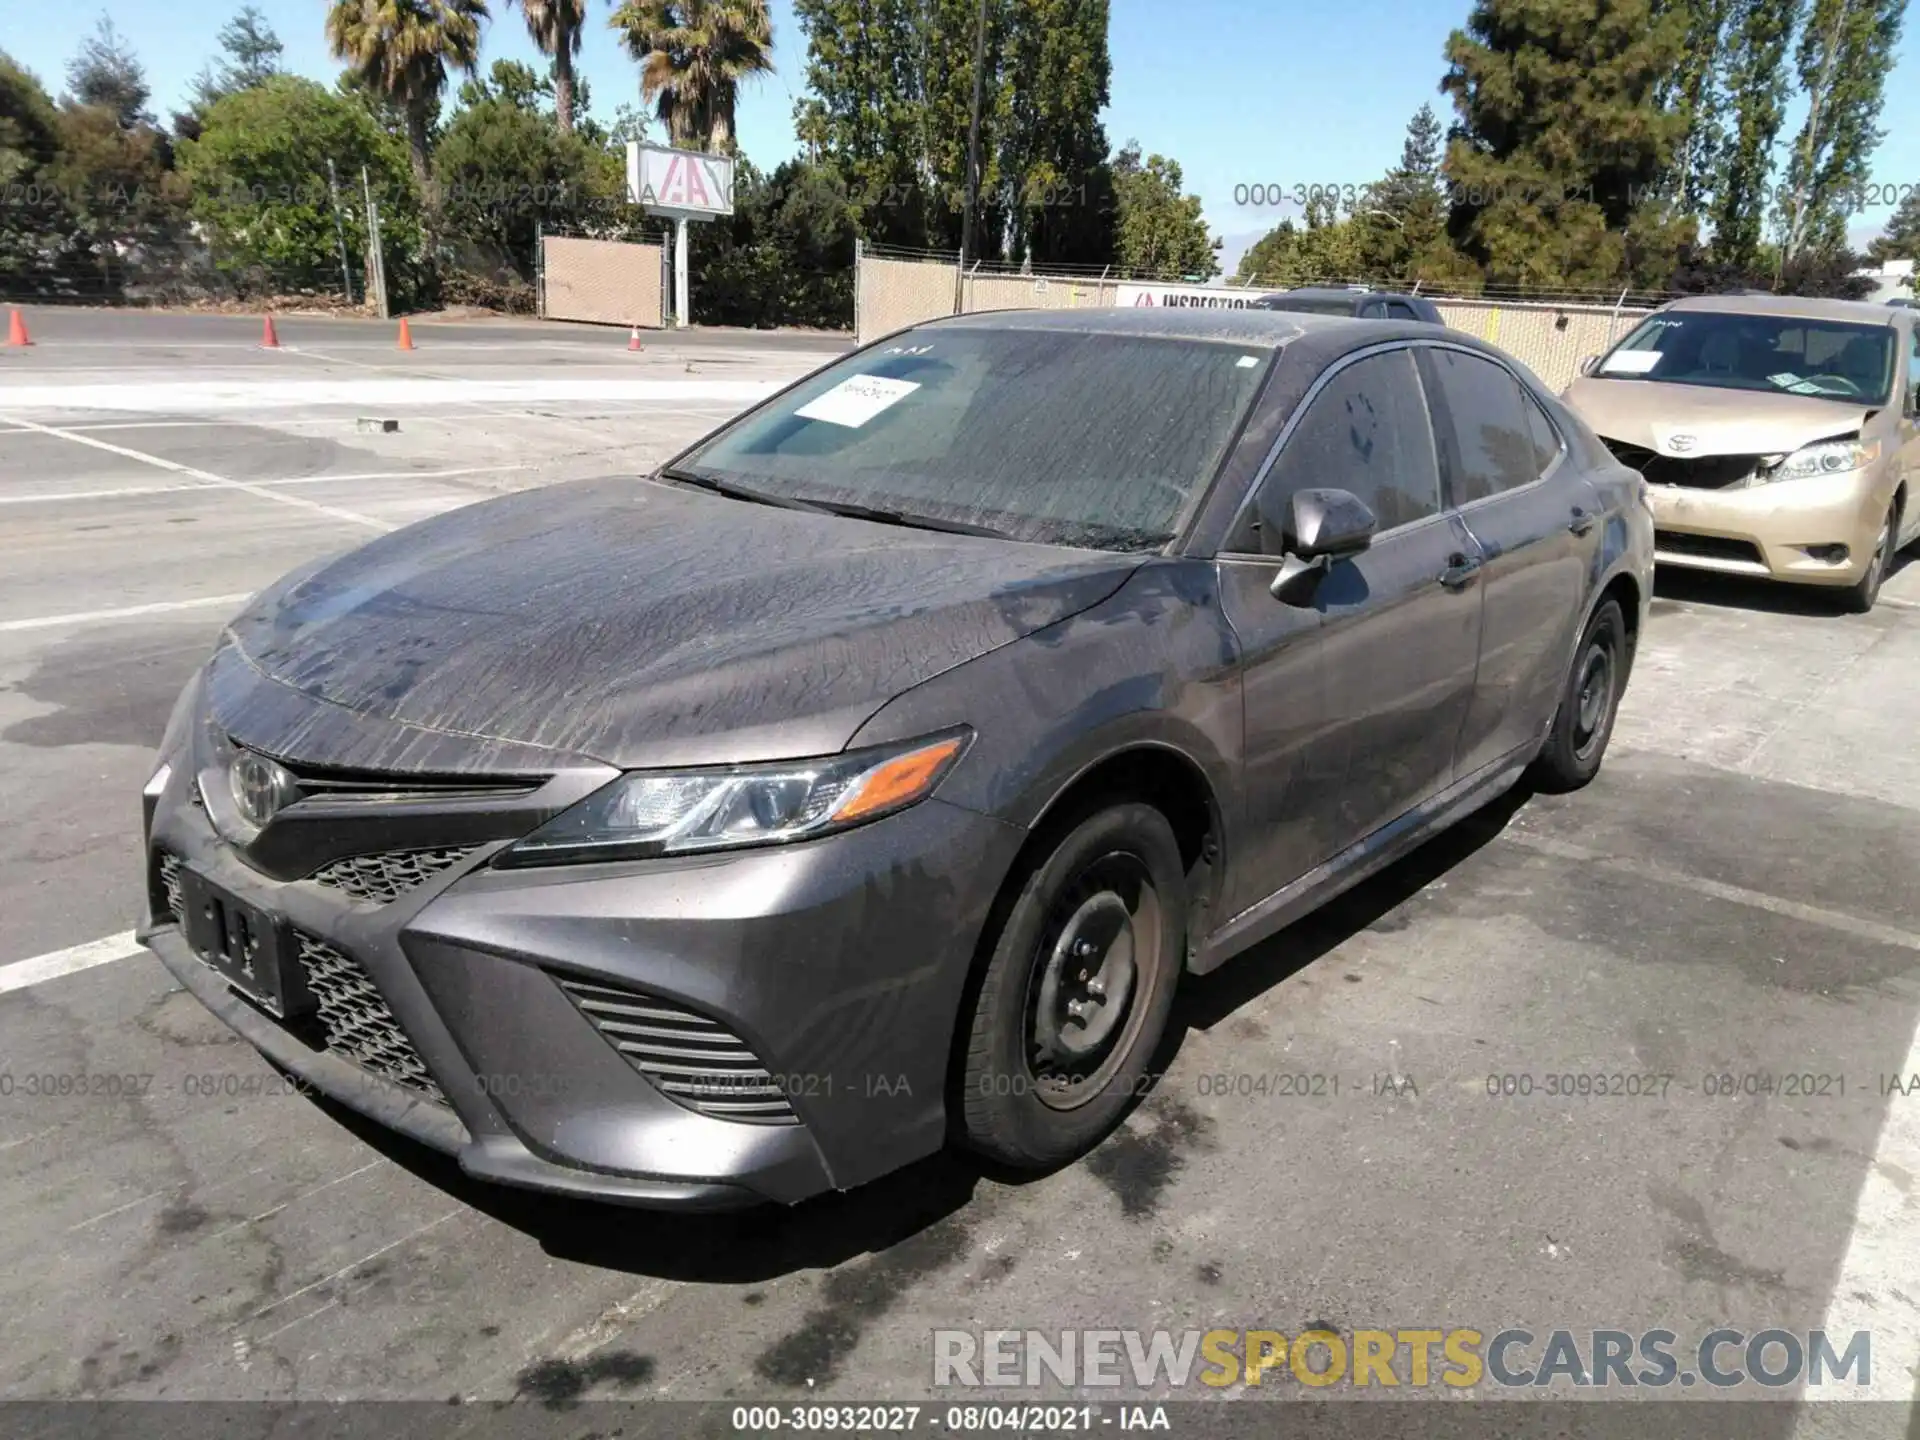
xmin=138 ymin=764 xmax=1023 ymax=1210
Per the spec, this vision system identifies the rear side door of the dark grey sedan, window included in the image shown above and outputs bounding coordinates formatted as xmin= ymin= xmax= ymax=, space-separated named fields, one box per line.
xmin=1419 ymin=346 xmax=1601 ymax=778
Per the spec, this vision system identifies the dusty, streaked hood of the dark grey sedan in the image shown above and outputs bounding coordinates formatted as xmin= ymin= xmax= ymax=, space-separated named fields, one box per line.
xmin=215 ymin=478 xmax=1140 ymax=768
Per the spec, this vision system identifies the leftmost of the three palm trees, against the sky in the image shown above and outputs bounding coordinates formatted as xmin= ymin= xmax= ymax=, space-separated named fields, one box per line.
xmin=326 ymin=0 xmax=488 ymax=198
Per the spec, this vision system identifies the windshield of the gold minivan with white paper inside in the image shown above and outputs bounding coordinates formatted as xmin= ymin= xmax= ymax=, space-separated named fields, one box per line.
xmin=1594 ymin=311 xmax=1893 ymax=405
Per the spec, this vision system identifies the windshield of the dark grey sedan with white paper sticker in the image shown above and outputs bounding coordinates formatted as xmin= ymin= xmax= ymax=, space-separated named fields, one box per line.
xmin=668 ymin=326 xmax=1273 ymax=549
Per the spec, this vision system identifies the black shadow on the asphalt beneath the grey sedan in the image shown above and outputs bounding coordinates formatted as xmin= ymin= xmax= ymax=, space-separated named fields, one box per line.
xmin=295 ymin=783 xmax=1532 ymax=1284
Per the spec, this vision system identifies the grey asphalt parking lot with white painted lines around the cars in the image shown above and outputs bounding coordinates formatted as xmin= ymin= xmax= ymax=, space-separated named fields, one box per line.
xmin=0 ymin=311 xmax=1920 ymax=1434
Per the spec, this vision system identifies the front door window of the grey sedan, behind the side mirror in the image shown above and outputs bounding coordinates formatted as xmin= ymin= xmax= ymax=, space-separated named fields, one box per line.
xmin=1227 ymin=349 xmax=1440 ymax=553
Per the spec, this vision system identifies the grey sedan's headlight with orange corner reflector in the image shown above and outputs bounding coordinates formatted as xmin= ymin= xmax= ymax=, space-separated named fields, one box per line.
xmin=493 ymin=732 xmax=972 ymax=866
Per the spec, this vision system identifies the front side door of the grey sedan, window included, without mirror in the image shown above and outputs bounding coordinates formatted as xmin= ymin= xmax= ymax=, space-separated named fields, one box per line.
xmin=1219 ymin=346 xmax=1480 ymax=910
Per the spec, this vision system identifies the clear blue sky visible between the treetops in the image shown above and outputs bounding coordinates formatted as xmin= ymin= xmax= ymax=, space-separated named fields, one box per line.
xmin=0 ymin=0 xmax=1920 ymax=273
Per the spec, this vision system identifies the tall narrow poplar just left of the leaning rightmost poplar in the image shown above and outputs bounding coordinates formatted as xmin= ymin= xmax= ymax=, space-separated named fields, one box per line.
xmin=1711 ymin=0 xmax=1803 ymax=269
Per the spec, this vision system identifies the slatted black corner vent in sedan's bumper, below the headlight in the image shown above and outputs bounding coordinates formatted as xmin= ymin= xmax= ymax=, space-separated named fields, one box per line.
xmin=555 ymin=975 xmax=801 ymax=1125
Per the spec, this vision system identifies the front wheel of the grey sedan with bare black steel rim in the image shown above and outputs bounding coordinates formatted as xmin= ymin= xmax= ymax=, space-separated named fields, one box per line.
xmin=958 ymin=801 xmax=1187 ymax=1169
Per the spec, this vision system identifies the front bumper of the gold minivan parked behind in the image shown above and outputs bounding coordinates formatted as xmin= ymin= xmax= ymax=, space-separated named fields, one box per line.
xmin=1647 ymin=468 xmax=1887 ymax=586
